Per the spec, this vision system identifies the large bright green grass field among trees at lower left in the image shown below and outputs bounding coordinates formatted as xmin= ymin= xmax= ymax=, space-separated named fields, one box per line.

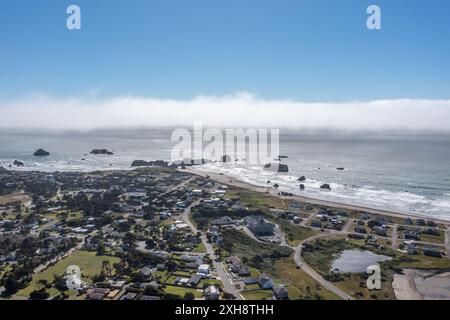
xmin=16 ymin=251 xmax=119 ymax=297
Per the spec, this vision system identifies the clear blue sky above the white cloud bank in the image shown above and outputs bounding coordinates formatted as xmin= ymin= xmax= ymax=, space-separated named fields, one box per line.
xmin=0 ymin=0 xmax=450 ymax=102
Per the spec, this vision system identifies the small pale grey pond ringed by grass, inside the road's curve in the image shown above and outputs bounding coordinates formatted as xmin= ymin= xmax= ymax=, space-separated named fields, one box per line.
xmin=331 ymin=250 xmax=392 ymax=273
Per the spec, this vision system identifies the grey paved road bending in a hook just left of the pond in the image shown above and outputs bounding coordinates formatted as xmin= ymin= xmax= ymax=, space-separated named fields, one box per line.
xmin=294 ymin=232 xmax=353 ymax=300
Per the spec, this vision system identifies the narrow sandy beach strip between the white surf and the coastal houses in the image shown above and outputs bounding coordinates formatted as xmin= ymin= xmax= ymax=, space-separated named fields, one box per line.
xmin=179 ymin=168 xmax=450 ymax=225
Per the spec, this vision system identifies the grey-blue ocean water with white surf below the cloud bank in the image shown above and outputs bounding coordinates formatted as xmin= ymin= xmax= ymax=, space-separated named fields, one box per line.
xmin=0 ymin=129 xmax=450 ymax=220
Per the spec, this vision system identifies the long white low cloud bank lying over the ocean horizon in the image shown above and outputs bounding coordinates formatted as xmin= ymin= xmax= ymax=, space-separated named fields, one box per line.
xmin=0 ymin=93 xmax=450 ymax=132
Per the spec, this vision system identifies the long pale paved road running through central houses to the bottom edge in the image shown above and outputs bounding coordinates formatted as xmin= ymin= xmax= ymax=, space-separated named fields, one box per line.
xmin=183 ymin=201 xmax=242 ymax=300
